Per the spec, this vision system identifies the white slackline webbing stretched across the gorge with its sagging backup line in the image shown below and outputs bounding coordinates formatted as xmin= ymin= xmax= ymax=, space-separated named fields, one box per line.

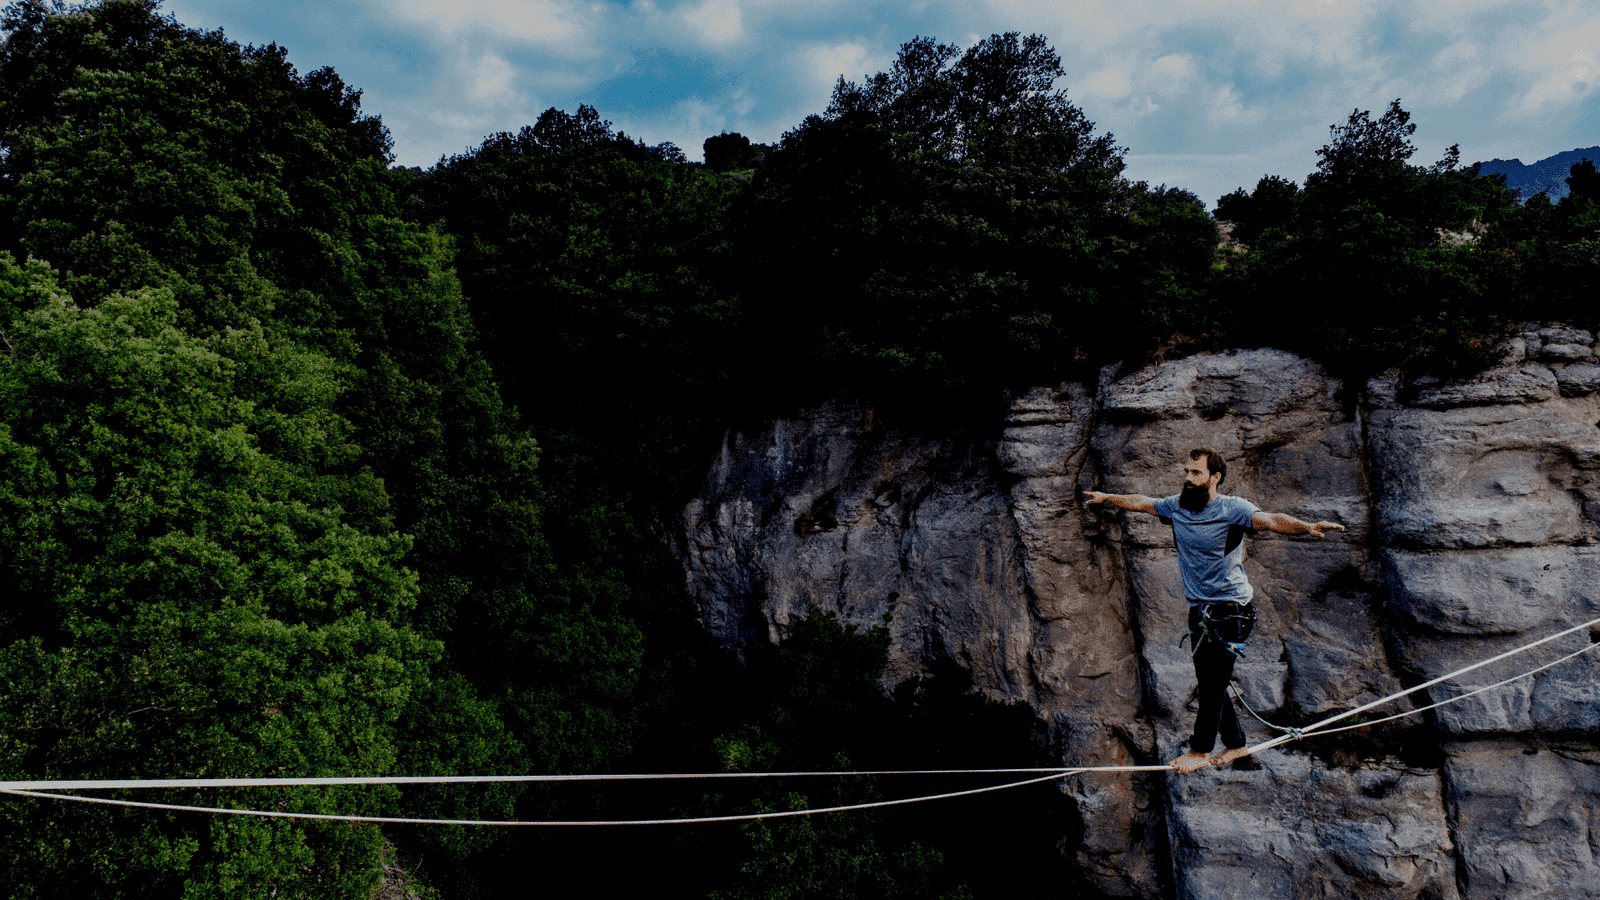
xmin=0 ymin=605 xmax=1600 ymax=826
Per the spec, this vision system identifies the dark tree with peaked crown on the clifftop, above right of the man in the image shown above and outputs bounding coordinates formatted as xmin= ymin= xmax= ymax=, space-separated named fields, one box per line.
xmin=1218 ymin=99 xmax=1512 ymax=376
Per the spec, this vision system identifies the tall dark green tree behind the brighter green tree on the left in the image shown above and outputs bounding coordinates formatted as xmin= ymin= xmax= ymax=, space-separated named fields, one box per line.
xmin=0 ymin=0 xmax=626 ymax=736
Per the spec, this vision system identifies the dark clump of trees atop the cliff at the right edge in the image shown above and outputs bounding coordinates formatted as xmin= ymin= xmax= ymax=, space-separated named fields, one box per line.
xmin=1216 ymin=99 xmax=1600 ymax=375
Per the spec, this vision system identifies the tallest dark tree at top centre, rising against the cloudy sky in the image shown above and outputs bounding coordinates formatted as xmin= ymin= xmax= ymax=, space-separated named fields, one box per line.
xmin=741 ymin=32 xmax=1216 ymax=407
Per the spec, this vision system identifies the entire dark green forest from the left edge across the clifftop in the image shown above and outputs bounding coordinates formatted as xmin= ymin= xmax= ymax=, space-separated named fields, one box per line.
xmin=0 ymin=0 xmax=1600 ymax=897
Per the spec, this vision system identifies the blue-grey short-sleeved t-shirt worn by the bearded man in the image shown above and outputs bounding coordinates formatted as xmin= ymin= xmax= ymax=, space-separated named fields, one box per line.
xmin=1155 ymin=493 xmax=1258 ymax=604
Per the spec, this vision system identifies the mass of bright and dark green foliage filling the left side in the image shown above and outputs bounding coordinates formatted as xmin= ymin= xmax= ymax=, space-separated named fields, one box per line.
xmin=0 ymin=0 xmax=640 ymax=897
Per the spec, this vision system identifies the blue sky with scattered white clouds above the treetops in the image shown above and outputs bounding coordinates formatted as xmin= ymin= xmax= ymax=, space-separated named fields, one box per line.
xmin=162 ymin=0 xmax=1600 ymax=205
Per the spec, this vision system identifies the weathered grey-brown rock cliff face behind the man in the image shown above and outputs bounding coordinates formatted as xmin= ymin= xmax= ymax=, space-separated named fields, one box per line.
xmin=677 ymin=327 xmax=1600 ymax=900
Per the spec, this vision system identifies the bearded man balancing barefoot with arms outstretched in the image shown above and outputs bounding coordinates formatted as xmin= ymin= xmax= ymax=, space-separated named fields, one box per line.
xmin=1083 ymin=448 xmax=1344 ymax=773
